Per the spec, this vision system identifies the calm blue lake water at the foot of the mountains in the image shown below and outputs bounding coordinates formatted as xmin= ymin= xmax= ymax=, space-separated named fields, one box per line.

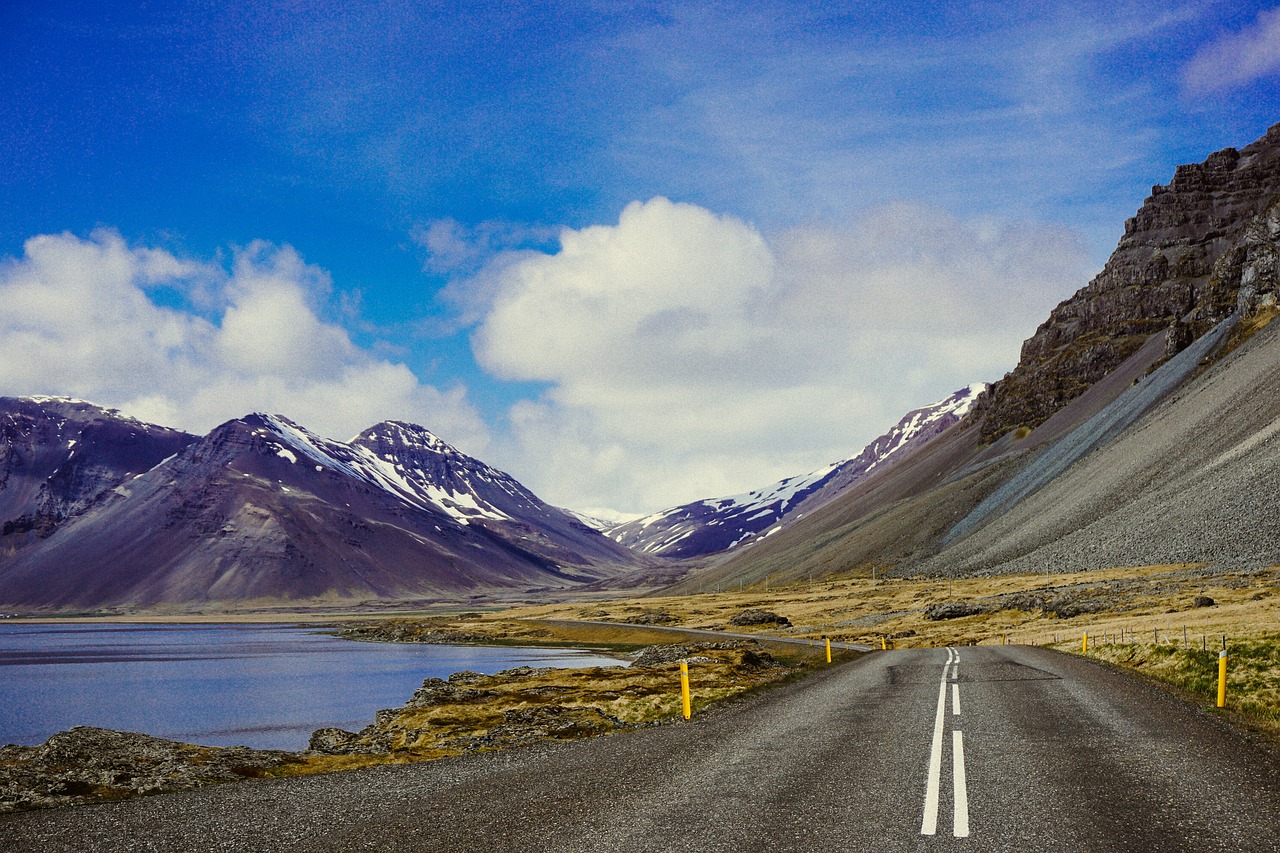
xmin=0 ymin=624 xmax=620 ymax=749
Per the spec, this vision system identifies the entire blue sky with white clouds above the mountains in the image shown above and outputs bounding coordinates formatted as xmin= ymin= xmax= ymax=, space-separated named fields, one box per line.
xmin=0 ymin=0 xmax=1280 ymax=511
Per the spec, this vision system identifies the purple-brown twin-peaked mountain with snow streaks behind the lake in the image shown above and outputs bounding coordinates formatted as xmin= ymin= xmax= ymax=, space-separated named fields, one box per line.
xmin=0 ymin=414 xmax=636 ymax=608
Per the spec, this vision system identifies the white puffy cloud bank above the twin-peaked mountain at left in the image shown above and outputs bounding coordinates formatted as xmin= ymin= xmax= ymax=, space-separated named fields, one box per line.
xmin=0 ymin=231 xmax=486 ymax=451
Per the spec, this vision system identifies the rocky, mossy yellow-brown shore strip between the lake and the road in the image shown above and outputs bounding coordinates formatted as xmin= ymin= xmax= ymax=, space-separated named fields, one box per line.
xmin=0 ymin=640 xmax=795 ymax=812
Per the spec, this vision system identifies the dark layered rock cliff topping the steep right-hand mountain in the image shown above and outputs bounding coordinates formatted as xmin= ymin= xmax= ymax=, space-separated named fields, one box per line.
xmin=978 ymin=124 xmax=1280 ymax=441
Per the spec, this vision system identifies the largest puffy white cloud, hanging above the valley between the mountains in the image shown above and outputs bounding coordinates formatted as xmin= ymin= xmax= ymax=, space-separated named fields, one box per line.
xmin=472 ymin=197 xmax=1088 ymax=511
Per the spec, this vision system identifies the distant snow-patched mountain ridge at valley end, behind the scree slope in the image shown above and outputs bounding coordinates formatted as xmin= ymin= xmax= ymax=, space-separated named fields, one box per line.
xmin=608 ymin=383 xmax=987 ymax=557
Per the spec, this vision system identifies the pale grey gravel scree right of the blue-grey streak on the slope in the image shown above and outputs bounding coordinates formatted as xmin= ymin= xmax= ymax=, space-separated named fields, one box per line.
xmin=922 ymin=315 xmax=1280 ymax=574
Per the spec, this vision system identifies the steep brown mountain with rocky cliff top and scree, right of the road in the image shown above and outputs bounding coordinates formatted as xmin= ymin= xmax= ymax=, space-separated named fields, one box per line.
xmin=671 ymin=126 xmax=1280 ymax=593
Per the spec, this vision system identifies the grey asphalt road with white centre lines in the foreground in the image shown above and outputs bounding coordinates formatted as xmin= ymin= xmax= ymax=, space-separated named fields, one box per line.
xmin=0 ymin=646 xmax=1280 ymax=852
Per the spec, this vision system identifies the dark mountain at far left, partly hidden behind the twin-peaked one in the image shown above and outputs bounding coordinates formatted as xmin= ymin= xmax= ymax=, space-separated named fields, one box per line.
xmin=0 ymin=397 xmax=196 ymax=555
